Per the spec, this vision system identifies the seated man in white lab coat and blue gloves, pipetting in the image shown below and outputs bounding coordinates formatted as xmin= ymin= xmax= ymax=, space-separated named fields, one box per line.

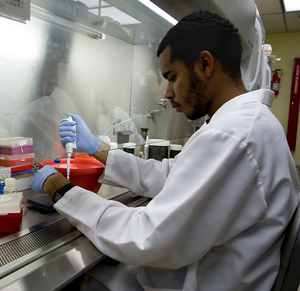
xmin=32 ymin=11 xmax=298 ymax=291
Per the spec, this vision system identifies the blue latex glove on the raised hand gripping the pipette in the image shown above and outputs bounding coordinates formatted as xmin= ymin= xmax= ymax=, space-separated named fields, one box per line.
xmin=59 ymin=114 xmax=102 ymax=156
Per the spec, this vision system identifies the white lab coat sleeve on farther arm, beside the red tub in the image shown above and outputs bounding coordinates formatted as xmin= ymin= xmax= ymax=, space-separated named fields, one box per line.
xmin=99 ymin=150 xmax=174 ymax=198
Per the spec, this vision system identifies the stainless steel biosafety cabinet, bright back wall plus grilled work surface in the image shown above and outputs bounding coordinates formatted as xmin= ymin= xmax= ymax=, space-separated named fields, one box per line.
xmin=0 ymin=0 xmax=203 ymax=290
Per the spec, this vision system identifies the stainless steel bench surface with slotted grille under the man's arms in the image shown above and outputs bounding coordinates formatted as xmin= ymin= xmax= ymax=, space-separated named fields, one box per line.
xmin=0 ymin=185 xmax=149 ymax=291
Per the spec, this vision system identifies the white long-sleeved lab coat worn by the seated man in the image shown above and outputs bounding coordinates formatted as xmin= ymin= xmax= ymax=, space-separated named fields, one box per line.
xmin=55 ymin=89 xmax=298 ymax=291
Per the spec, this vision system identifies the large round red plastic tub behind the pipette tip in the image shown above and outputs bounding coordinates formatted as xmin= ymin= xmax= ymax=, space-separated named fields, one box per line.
xmin=39 ymin=158 xmax=105 ymax=193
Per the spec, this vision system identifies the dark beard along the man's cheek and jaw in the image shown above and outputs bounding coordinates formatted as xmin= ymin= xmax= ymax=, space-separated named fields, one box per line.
xmin=184 ymin=69 xmax=208 ymax=120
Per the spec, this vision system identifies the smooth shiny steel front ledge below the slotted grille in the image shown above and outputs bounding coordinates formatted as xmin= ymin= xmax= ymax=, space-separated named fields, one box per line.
xmin=0 ymin=236 xmax=105 ymax=291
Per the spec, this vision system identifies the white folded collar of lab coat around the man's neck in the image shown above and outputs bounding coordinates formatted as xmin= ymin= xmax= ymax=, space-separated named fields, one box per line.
xmin=211 ymin=89 xmax=274 ymax=120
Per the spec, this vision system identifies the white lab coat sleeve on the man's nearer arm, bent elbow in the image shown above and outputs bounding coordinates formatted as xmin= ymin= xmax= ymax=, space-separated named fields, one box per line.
xmin=55 ymin=131 xmax=267 ymax=269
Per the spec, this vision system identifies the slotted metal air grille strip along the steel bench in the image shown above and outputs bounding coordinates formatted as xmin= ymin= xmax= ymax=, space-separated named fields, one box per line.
xmin=0 ymin=219 xmax=76 ymax=267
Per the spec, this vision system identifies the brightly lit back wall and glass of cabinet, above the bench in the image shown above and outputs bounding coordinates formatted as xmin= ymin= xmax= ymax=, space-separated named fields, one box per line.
xmin=0 ymin=0 xmax=202 ymax=163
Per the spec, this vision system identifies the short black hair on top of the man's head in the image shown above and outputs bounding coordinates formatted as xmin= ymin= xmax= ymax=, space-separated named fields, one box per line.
xmin=157 ymin=11 xmax=243 ymax=81
